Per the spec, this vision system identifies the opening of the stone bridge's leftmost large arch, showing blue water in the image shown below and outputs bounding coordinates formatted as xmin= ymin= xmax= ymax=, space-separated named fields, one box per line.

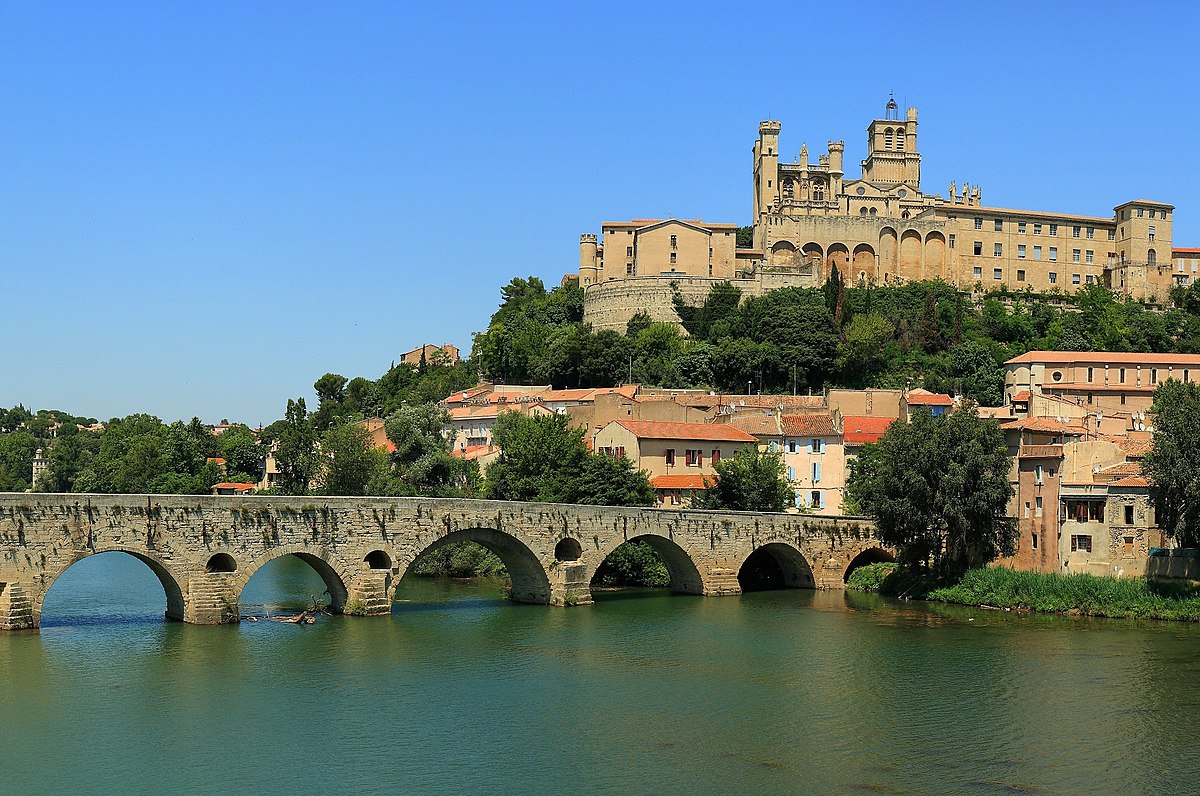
xmin=35 ymin=551 xmax=184 ymax=628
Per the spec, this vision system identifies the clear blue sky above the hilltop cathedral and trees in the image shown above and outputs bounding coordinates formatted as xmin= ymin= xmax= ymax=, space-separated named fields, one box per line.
xmin=0 ymin=1 xmax=1200 ymax=424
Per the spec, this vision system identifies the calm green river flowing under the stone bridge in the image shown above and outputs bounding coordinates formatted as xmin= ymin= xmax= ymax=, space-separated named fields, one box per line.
xmin=0 ymin=553 xmax=1200 ymax=795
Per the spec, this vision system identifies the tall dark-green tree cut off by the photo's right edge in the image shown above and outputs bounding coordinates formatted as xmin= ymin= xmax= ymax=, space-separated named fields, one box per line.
xmin=1141 ymin=378 xmax=1200 ymax=547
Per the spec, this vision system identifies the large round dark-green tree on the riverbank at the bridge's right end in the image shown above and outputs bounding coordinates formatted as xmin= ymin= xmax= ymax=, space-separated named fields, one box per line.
xmin=847 ymin=406 xmax=1016 ymax=576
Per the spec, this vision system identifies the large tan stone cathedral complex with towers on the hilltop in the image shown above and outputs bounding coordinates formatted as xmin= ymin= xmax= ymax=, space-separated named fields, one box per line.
xmin=580 ymin=100 xmax=1176 ymax=329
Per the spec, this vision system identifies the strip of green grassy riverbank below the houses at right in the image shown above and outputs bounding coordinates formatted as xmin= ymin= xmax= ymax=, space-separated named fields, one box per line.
xmin=846 ymin=563 xmax=1200 ymax=622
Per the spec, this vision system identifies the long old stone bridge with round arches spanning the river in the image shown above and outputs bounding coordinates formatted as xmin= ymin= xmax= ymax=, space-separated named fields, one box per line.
xmin=0 ymin=493 xmax=890 ymax=630
